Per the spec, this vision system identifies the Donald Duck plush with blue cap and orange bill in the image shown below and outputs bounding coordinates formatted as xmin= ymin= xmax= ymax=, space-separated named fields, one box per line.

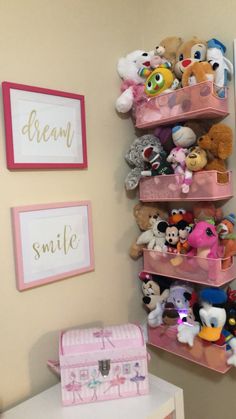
xmin=177 ymin=288 xmax=236 ymax=367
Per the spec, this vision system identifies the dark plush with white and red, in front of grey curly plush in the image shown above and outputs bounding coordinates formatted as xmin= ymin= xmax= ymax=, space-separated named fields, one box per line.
xmin=141 ymin=146 xmax=174 ymax=176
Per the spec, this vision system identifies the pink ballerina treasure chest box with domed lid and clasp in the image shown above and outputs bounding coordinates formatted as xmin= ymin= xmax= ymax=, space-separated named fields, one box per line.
xmin=59 ymin=324 xmax=148 ymax=405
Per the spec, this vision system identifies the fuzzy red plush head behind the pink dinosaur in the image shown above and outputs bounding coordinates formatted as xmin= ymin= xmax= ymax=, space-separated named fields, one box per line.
xmin=193 ymin=201 xmax=223 ymax=224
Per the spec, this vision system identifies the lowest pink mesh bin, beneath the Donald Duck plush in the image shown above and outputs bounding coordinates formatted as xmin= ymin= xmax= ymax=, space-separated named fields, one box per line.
xmin=148 ymin=326 xmax=231 ymax=374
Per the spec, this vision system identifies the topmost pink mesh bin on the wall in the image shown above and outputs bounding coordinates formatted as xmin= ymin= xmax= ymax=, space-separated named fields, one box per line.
xmin=136 ymin=81 xmax=229 ymax=128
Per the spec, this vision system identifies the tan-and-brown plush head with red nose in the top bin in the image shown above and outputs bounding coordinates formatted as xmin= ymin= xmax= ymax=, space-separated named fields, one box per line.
xmin=174 ymin=36 xmax=207 ymax=80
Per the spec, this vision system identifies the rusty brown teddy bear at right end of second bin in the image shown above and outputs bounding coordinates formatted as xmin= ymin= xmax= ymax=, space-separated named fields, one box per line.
xmin=198 ymin=123 xmax=233 ymax=183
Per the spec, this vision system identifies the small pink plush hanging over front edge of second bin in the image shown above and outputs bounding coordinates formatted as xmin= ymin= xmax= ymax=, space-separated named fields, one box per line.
xmin=166 ymin=147 xmax=192 ymax=193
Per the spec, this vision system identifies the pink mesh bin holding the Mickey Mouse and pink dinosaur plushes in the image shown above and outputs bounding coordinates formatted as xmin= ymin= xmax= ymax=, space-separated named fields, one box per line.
xmin=143 ymin=249 xmax=236 ymax=287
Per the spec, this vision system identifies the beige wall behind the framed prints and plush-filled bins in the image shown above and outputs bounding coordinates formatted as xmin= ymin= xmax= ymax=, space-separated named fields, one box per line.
xmin=0 ymin=0 xmax=236 ymax=419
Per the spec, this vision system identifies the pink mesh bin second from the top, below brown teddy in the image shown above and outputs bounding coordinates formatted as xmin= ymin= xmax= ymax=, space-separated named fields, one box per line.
xmin=139 ymin=170 xmax=233 ymax=202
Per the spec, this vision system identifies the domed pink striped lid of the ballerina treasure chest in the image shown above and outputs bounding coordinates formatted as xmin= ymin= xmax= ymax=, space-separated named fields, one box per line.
xmin=60 ymin=323 xmax=145 ymax=355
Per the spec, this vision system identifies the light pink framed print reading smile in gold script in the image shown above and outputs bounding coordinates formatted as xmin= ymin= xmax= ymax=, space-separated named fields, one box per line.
xmin=12 ymin=201 xmax=94 ymax=291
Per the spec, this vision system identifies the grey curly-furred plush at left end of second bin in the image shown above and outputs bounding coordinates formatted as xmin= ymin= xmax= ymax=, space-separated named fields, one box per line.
xmin=125 ymin=134 xmax=163 ymax=191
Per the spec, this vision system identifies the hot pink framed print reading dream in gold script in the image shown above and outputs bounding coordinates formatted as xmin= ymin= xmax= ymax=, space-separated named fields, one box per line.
xmin=2 ymin=81 xmax=87 ymax=169
